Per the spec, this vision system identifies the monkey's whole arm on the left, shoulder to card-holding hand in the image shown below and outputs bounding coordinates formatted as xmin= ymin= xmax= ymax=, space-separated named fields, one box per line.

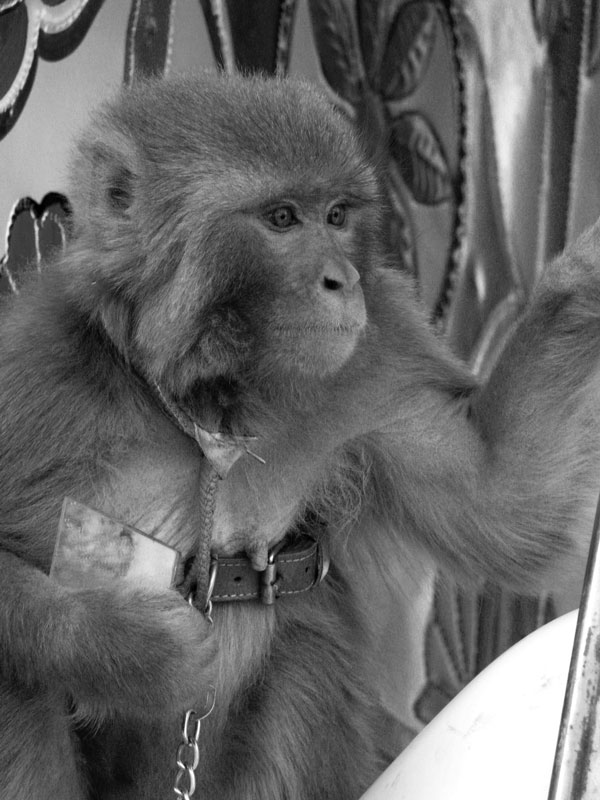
xmin=0 ymin=281 xmax=218 ymax=716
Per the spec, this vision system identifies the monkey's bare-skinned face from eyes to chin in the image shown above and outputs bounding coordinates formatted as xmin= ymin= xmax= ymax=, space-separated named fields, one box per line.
xmin=248 ymin=196 xmax=367 ymax=377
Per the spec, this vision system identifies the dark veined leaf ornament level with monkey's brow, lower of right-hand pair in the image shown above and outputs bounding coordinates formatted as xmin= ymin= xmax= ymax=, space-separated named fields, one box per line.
xmin=390 ymin=111 xmax=453 ymax=205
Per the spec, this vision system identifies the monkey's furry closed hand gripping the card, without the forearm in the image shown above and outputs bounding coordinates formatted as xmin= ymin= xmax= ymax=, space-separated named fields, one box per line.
xmin=63 ymin=588 xmax=214 ymax=717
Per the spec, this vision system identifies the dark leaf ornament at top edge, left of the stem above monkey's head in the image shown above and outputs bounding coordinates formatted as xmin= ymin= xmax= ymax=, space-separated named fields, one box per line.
xmin=309 ymin=0 xmax=363 ymax=105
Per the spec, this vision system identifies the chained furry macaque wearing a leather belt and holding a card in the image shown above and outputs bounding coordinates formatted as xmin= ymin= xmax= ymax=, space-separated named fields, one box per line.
xmin=0 ymin=70 xmax=600 ymax=800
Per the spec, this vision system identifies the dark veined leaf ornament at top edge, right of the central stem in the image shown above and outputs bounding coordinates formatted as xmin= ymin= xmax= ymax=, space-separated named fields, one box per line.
xmin=379 ymin=0 xmax=437 ymax=101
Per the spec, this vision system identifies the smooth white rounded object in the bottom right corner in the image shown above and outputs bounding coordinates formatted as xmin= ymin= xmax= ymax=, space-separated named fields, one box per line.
xmin=362 ymin=611 xmax=577 ymax=800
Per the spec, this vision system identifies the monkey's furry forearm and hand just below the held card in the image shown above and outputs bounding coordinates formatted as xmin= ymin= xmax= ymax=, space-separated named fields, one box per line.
xmin=0 ymin=553 xmax=215 ymax=719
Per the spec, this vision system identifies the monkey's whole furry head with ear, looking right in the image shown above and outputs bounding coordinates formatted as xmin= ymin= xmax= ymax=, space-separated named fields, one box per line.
xmin=65 ymin=74 xmax=383 ymax=418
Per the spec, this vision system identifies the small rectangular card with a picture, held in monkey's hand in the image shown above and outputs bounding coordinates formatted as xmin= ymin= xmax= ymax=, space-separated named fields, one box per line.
xmin=50 ymin=497 xmax=180 ymax=589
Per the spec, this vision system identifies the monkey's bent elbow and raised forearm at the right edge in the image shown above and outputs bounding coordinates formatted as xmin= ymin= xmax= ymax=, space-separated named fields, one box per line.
xmin=366 ymin=226 xmax=600 ymax=591
